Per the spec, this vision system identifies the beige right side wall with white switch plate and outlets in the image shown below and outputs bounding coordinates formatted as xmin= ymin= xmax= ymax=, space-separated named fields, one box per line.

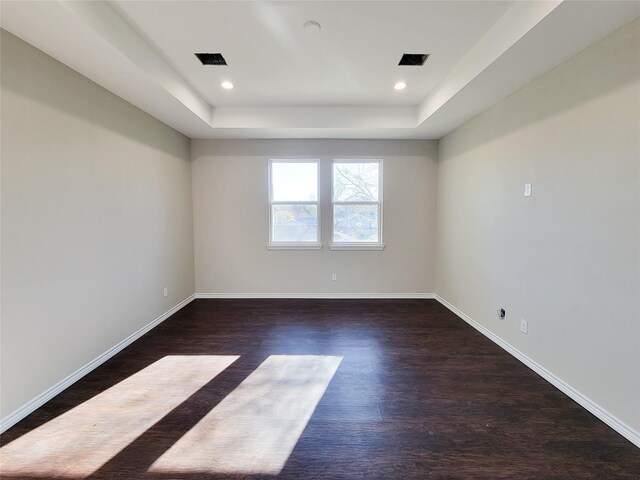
xmin=436 ymin=21 xmax=640 ymax=431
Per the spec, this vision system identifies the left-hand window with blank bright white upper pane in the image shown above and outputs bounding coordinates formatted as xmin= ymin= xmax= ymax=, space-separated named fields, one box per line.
xmin=269 ymin=160 xmax=322 ymax=249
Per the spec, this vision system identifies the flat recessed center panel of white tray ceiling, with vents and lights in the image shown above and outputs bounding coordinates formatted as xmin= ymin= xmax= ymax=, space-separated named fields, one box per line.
xmin=115 ymin=1 xmax=512 ymax=106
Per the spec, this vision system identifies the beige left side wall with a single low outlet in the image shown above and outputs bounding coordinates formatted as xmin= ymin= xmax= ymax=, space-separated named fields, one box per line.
xmin=1 ymin=31 xmax=194 ymax=418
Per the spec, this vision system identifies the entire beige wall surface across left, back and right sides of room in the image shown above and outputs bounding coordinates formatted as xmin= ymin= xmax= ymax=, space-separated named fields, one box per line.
xmin=0 ymin=14 xmax=640 ymax=442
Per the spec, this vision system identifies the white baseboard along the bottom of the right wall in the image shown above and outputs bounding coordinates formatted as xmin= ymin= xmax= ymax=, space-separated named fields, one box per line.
xmin=434 ymin=294 xmax=640 ymax=447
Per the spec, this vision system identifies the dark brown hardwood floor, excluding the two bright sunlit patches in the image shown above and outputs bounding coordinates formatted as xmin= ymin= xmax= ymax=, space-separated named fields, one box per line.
xmin=1 ymin=300 xmax=640 ymax=480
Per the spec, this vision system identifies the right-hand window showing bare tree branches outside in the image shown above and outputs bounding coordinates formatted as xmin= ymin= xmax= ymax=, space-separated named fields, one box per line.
xmin=331 ymin=160 xmax=384 ymax=250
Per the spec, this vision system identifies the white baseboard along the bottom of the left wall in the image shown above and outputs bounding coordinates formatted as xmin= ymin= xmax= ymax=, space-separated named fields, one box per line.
xmin=0 ymin=294 xmax=196 ymax=433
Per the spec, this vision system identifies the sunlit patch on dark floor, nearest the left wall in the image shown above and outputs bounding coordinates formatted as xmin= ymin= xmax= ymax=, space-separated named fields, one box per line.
xmin=0 ymin=355 xmax=240 ymax=478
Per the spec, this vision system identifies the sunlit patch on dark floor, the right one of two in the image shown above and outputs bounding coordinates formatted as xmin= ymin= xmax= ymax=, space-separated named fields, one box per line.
xmin=149 ymin=355 xmax=342 ymax=475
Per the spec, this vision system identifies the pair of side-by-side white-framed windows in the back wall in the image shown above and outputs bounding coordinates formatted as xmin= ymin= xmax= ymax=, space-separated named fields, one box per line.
xmin=269 ymin=160 xmax=383 ymax=250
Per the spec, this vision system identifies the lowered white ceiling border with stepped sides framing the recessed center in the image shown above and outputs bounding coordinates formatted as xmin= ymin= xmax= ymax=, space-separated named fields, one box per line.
xmin=0 ymin=0 xmax=640 ymax=138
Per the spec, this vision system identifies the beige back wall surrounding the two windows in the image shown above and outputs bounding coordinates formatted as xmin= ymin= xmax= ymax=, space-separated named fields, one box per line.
xmin=191 ymin=140 xmax=437 ymax=294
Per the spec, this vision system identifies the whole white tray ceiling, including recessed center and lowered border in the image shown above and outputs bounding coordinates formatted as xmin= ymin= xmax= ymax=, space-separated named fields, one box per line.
xmin=0 ymin=0 xmax=640 ymax=138
